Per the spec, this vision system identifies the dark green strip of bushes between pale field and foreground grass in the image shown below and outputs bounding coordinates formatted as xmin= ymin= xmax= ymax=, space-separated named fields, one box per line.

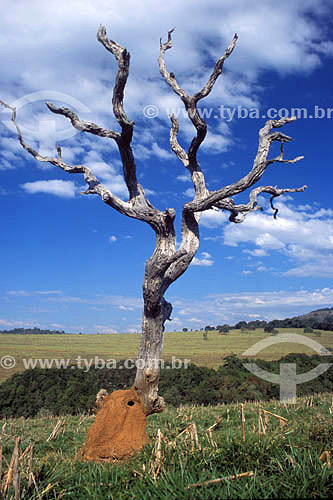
xmin=0 ymin=354 xmax=333 ymax=418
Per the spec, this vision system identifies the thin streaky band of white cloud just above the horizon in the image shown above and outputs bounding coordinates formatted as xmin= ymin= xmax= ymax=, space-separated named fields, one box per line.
xmin=0 ymin=287 xmax=333 ymax=333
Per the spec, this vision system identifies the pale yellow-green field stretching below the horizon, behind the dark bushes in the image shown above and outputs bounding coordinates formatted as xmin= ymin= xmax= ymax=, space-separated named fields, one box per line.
xmin=0 ymin=328 xmax=333 ymax=382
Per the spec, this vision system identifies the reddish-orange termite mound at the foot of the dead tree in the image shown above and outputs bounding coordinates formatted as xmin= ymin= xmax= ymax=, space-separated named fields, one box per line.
xmin=78 ymin=389 xmax=149 ymax=462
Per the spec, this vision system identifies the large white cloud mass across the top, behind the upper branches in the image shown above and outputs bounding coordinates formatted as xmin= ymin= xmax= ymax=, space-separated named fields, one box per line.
xmin=0 ymin=0 xmax=333 ymax=168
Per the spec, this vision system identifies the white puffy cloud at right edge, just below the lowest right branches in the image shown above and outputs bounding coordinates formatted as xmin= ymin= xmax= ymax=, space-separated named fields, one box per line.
xmin=220 ymin=202 xmax=333 ymax=278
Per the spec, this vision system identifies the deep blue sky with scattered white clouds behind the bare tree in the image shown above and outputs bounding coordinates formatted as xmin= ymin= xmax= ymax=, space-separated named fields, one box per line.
xmin=0 ymin=0 xmax=333 ymax=333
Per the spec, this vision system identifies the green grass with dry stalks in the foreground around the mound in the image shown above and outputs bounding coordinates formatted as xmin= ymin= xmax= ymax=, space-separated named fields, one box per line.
xmin=0 ymin=394 xmax=333 ymax=500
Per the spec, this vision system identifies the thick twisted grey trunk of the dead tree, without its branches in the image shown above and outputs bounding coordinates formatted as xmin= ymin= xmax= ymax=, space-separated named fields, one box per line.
xmin=134 ymin=209 xmax=200 ymax=415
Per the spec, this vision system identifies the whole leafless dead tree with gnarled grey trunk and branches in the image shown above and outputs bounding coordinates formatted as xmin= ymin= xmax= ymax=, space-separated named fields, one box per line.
xmin=0 ymin=26 xmax=306 ymax=415
